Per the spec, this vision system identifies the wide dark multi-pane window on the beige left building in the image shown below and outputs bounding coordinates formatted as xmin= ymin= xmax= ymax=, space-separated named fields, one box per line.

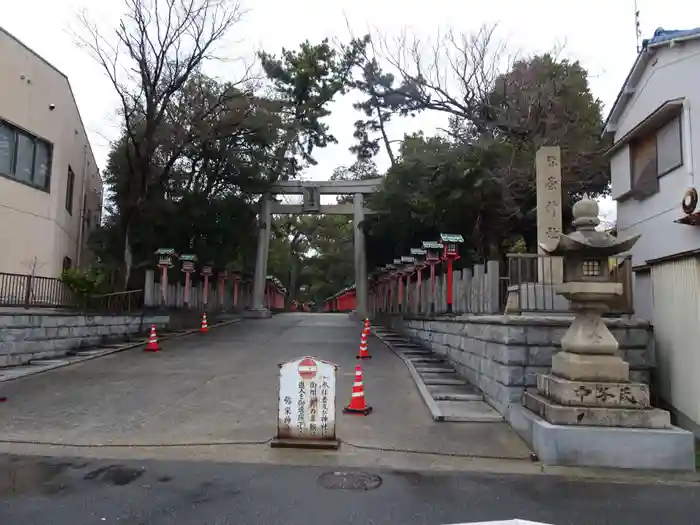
xmin=0 ymin=120 xmax=53 ymax=191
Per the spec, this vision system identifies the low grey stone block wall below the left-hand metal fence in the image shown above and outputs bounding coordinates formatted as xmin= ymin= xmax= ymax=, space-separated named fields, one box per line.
xmin=0 ymin=313 xmax=168 ymax=366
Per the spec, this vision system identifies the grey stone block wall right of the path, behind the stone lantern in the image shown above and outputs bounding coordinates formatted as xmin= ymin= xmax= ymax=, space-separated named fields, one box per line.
xmin=392 ymin=315 xmax=654 ymax=418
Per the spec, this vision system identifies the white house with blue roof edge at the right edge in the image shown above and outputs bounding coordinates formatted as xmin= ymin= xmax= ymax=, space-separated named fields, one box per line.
xmin=605 ymin=29 xmax=700 ymax=435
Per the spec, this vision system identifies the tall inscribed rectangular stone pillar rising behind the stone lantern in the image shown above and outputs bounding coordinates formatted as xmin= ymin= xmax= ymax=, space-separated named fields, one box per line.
xmin=535 ymin=146 xmax=563 ymax=284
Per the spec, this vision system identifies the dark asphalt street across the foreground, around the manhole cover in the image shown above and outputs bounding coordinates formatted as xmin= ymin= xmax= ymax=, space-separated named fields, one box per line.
xmin=0 ymin=456 xmax=700 ymax=525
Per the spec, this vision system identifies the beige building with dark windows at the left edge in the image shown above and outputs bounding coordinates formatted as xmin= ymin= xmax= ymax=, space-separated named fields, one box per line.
xmin=0 ymin=28 xmax=102 ymax=278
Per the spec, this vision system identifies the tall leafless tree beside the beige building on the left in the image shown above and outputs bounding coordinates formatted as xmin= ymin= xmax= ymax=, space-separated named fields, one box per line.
xmin=76 ymin=0 xmax=242 ymax=288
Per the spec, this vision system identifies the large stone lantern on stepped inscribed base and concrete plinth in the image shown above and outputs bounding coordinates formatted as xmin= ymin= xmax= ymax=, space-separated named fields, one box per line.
xmin=510 ymin=199 xmax=695 ymax=469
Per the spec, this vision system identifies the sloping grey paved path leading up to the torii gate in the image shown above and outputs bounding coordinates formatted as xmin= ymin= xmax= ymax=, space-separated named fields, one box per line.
xmin=0 ymin=313 xmax=529 ymax=468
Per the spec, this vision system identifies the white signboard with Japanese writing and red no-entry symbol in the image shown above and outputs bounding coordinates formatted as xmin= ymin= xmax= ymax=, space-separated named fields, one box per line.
xmin=277 ymin=357 xmax=338 ymax=441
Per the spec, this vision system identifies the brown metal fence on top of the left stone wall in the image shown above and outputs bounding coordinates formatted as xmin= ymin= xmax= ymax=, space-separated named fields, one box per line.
xmin=0 ymin=272 xmax=143 ymax=312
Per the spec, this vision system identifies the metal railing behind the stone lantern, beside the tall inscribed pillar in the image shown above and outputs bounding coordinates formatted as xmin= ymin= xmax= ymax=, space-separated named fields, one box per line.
xmin=501 ymin=253 xmax=634 ymax=316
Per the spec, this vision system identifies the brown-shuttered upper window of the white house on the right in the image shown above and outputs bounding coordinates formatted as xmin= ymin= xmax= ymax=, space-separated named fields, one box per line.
xmin=630 ymin=116 xmax=683 ymax=198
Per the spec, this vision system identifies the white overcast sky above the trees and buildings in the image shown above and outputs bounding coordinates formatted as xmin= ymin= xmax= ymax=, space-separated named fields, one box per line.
xmin=5 ymin=0 xmax=700 ymax=222
